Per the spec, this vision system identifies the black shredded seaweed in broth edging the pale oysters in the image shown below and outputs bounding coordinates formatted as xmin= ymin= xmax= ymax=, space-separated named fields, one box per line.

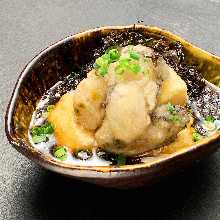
xmin=30 ymin=30 xmax=220 ymax=165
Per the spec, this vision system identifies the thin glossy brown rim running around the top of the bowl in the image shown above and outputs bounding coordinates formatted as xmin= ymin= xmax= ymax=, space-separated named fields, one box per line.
xmin=5 ymin=24 xmax=220 ymax=173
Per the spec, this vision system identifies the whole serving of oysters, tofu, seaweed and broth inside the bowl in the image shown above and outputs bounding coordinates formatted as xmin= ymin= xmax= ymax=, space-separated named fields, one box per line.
xmin=30 ymin=32 xmax=219 ymax=166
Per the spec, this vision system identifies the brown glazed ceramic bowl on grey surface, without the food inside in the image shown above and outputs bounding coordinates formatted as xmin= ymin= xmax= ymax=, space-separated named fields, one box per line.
xmin=5 ymin=25 xmax=220 ymax=188
